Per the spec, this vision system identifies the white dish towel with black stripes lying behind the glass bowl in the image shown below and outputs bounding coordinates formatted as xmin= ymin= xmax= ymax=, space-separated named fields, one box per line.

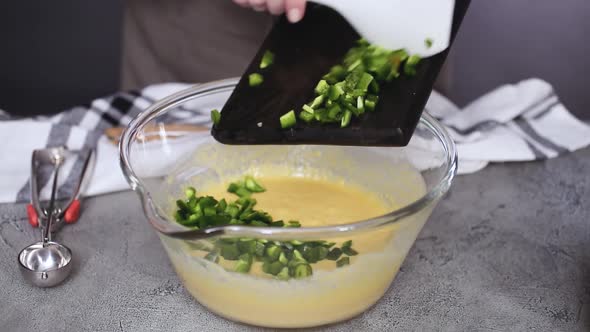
xmin=0 ymin=79 xmax=590 ymax=203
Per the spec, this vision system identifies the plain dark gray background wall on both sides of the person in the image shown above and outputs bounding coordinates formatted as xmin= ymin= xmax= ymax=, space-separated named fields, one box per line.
xmin=0 ymin=0 xmax=590 ymax=118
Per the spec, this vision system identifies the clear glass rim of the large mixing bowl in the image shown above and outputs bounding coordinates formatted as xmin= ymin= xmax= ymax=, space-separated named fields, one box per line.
xmin=119 ymin=78 xmax=457 ymax=240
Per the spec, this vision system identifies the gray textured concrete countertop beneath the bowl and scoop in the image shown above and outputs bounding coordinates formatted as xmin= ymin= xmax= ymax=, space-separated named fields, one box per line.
xmin=0 ymin=149 xmax=590 ymax=332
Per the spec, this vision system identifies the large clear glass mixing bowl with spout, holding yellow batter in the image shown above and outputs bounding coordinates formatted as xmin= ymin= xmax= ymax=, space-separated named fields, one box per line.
xmin=119 ymin=79 xmax=457 ymax=328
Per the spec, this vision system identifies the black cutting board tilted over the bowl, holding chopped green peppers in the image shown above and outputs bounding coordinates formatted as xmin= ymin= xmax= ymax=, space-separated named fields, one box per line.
xmin=212 ymin=0 xmax=470 ymax=146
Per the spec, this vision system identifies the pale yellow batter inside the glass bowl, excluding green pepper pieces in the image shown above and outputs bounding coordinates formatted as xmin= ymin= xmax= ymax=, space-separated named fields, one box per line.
xmin=162 ymin=172 xmax=429 ymax=327
